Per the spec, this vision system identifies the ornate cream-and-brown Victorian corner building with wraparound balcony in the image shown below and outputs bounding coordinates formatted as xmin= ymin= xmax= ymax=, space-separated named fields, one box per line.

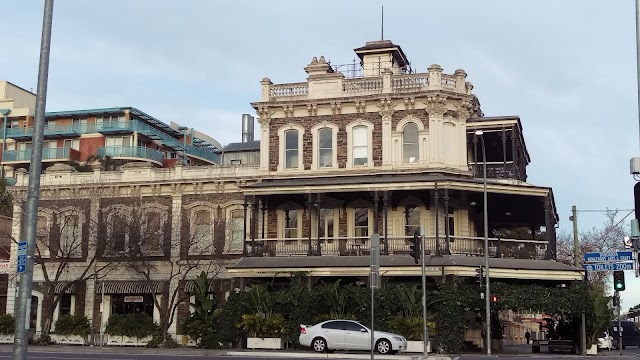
xmin=3 ymin=41 xmax=582 ymax=342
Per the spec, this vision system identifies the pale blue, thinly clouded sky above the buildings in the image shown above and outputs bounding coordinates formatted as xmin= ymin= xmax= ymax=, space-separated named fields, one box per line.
xmin=0 ymin=0 xmax=640 ymax=309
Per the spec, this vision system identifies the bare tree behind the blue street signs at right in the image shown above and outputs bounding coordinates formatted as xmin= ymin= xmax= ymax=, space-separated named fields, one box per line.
xmin=557 ymin=210 xmax=631 ymax=289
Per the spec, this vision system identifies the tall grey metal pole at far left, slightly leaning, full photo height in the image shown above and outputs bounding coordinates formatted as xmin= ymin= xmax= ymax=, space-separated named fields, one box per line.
xmin=13 ymin=0 xmax=53 ymax=360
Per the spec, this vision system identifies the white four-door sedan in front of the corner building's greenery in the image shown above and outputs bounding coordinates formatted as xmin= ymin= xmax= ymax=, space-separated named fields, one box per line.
xmin=299 ymin=320 xmax=407 ymax=354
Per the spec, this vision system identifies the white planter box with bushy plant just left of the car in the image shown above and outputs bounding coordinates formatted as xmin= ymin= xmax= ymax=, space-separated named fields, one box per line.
xmin=237 ymin=314 xmax=289 ymax=349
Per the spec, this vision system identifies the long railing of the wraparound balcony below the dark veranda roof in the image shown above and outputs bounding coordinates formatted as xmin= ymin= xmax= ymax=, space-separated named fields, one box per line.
xmin=246 ymin=236 xmax=547 ymax=259
